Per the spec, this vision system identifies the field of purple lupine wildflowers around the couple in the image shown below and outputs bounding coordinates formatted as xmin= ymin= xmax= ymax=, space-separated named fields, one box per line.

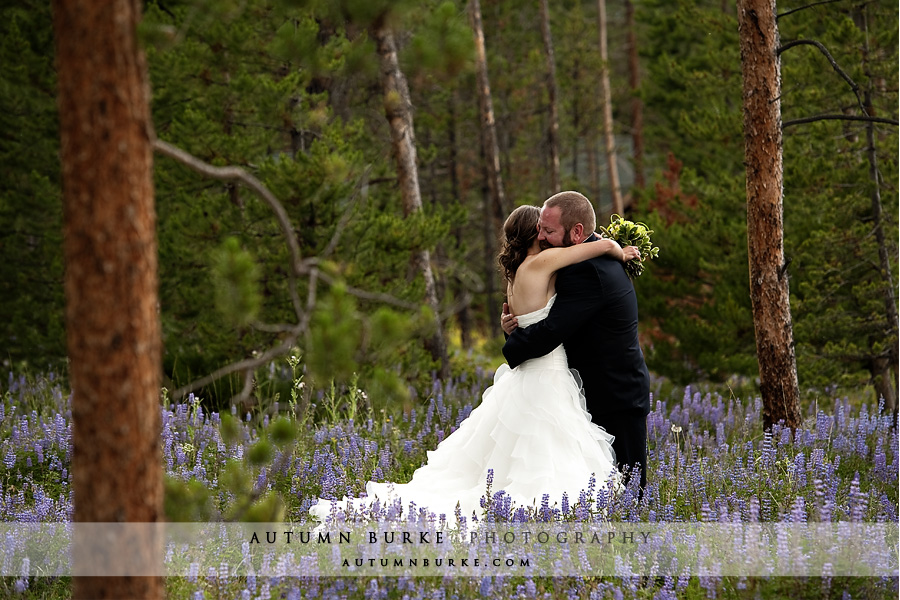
xmin=0 ymin=368 xmax=898 ymax=600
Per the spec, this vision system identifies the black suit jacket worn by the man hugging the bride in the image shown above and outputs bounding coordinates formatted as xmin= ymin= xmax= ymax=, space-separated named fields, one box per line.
xmin=503 ymin=236 xmax=650 ymax=426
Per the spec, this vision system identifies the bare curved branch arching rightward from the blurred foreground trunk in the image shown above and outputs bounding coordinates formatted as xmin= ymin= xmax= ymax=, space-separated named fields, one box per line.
xmin=153 ymin=139 xmax=303 ymax=319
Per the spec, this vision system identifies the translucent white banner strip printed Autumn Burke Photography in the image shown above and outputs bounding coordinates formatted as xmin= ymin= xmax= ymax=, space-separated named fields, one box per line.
xmin=0 ymin=522 xmax=898 ymax=577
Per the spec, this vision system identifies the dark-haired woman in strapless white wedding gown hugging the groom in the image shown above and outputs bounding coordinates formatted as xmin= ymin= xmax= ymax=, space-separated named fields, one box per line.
xmin=309 ymin=206 xmax=639 ymax=522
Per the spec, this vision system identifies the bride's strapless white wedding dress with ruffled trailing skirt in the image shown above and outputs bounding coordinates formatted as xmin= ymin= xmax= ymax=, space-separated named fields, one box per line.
xmin=309 ymin=295 xmax=615 ymax=522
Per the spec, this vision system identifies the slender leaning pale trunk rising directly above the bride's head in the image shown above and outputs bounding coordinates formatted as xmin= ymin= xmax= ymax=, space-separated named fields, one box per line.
xmin=469 ymin=0 xmax=509 ymax=227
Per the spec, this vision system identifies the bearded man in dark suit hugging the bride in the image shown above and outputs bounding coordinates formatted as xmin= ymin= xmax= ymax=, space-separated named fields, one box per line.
xmin=501 ymin=192 xmax=650 ymax=489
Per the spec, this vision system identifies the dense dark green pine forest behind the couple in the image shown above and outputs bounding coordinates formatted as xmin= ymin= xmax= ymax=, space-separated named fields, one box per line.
xmin=0 ymin=0 xmax=898 ymax=409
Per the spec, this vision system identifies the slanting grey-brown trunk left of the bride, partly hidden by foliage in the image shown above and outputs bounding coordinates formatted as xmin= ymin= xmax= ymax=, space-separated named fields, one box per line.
xmin=372 ymin=14 xmax=450 ymax=379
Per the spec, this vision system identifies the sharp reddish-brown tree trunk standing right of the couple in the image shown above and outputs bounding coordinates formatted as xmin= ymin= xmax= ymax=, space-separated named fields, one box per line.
xmin=737 ymin=0 xmax=800 ymax=428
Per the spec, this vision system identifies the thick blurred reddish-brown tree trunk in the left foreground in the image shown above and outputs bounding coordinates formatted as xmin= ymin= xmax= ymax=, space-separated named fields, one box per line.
xmin=53 ymin=0 xmax=164 ymax=598
